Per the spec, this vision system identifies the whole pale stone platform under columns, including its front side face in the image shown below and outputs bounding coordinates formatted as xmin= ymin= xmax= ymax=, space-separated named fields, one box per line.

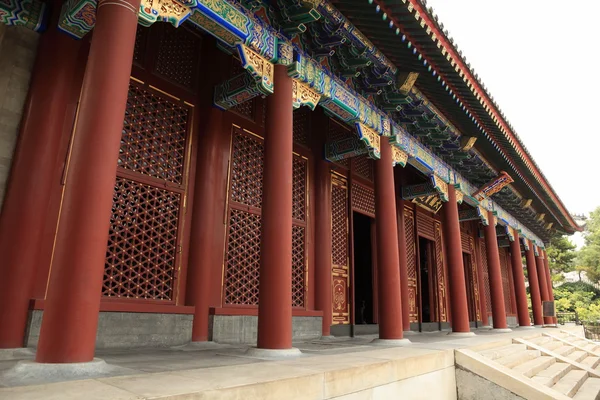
xmin=0 ymin=327 xmax=581 ymax=400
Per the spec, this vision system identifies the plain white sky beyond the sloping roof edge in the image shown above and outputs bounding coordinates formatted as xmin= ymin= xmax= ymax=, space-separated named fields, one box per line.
xmin=427 ymin=0 xmax=600 ymax=244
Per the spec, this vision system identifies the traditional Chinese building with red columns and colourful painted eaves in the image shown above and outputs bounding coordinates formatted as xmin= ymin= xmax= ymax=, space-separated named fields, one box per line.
xmin=0 ymin=0 xmax=578 ymax=362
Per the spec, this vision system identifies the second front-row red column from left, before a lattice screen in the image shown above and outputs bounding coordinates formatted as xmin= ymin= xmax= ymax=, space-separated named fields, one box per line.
xmin=258 ymin=65 xmax=293 ymax=349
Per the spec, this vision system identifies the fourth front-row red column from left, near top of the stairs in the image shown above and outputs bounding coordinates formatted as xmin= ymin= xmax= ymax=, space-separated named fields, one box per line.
xmin=442 ymin=185 xmax=471 ymax=333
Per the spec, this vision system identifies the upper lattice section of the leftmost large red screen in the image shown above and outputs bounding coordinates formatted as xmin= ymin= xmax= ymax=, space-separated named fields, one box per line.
xmin=119 ymin=83 xmax=189 ymax=184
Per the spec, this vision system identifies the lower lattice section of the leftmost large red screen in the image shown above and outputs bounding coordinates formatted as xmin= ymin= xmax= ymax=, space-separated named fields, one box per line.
xmin=102 ymin=177 xmax=181 ymax=300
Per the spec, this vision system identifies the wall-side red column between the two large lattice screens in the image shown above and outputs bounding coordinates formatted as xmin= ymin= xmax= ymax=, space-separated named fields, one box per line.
xmin=186 ymin=108 xmax=224 ymax=342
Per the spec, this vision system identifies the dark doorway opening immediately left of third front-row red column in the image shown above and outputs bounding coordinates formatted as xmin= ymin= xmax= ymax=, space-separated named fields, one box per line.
xmin=352 ymin=212 xmax=377 ymax=325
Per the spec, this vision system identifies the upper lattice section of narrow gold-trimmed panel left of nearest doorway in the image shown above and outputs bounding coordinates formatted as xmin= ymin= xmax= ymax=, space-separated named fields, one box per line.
xmin=331 ymin=178 xmax=348 ymax=265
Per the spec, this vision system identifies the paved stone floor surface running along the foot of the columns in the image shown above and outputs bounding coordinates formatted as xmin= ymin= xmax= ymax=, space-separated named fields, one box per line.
xmin=0 ymin=328 xmax=584 ymax=400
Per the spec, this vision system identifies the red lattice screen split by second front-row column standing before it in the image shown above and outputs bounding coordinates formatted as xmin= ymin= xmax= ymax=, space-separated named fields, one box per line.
xmin=224 ymin=127 xmax=308 ymax=307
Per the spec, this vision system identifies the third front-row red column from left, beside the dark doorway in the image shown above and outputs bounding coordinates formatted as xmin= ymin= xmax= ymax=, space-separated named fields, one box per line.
xmin=375 ymin=142 xmax=403 ymax=340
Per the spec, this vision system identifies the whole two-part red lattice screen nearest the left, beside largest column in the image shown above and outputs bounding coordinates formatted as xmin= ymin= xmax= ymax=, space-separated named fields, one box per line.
xmin=102 ymin=82 xmax=191 ymax=300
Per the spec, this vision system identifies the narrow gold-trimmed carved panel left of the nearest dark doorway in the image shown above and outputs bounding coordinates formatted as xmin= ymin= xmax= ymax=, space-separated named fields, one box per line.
xmin=331 ymin=174 xmax=350 ymax=324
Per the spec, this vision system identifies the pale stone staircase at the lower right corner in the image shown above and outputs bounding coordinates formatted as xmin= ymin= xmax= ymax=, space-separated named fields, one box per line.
xmin=457 ymin=331 xmax=600 ymax=400
